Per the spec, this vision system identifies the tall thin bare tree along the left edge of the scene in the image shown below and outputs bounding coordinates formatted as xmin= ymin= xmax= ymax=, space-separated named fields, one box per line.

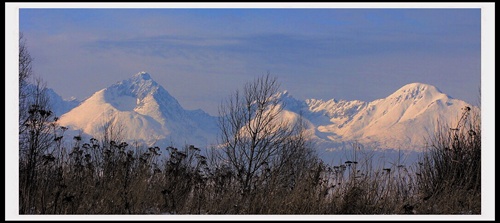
xmin=19 ymin=33 xmax=57 ymax=213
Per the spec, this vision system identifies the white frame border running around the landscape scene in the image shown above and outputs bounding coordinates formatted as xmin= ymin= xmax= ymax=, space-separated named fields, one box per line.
xmin=5 ymin=3 xmax=495 ymax=220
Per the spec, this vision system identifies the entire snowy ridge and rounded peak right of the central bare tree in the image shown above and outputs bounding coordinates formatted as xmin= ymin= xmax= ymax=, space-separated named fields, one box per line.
xmin=282 ymin=83 xmax=478 ymax=150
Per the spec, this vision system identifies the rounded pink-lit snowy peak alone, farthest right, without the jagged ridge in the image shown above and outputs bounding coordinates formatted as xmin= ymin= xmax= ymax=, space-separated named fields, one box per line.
xmin=334 ymin=83 xmax=469 ymax=149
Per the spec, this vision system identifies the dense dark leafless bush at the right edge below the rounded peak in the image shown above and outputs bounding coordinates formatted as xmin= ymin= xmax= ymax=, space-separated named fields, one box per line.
xmin=417 ymin=107 xmax=481 ymax=214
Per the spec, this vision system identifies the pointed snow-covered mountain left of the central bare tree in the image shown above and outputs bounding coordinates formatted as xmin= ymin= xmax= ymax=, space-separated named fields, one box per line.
xmin=59 ymin=72 xmax=217 ymax=146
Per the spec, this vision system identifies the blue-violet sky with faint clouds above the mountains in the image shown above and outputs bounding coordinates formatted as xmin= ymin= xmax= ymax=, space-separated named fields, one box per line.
xmin=19 ymin=4 xmax=481 ymax=115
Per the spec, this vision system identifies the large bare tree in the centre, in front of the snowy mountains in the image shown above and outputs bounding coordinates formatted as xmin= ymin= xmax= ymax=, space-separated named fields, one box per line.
xmin=219 ymin=74 xmax=304 ymax=195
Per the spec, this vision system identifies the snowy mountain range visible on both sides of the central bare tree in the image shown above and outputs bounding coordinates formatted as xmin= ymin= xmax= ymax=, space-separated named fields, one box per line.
xmin=51 ymin=72 xmax=478 ymax=155
